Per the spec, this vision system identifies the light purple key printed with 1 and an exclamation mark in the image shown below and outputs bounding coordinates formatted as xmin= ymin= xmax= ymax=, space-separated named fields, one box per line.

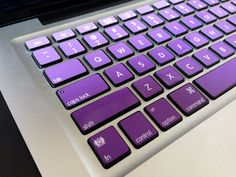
xmin=59 ymin=39 xmax=86 ymax=58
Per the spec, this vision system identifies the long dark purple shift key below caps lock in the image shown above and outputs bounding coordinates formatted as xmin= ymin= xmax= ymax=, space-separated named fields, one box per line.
xmin=71 ymin=87 xmax=140 ymax=134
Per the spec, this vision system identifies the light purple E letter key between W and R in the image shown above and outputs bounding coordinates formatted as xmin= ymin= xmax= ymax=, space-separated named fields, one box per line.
xmin=128 ymin=34 xmax=153 ymax=52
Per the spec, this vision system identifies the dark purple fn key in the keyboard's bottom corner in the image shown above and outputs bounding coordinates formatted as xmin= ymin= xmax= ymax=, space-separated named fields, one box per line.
xmin=88 ymin=126 xmax=131 ymax=169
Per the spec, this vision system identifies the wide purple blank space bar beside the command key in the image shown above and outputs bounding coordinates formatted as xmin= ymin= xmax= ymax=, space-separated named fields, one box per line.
xmin=194 ymin=58 xmax=236 ymax=99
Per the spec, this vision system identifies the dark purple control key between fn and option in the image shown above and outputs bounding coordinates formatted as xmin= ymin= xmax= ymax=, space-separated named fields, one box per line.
xmin=119 ymin=112 xmax=158 ymax=148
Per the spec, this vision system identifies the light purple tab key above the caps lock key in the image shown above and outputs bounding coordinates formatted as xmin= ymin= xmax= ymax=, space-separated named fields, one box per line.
xmin=44 ymin=59 xmax=87 ymax=87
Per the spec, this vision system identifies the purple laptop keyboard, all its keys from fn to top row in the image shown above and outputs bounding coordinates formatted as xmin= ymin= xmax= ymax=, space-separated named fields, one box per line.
xmin=25 ymin=0 xmax=236 ymax=168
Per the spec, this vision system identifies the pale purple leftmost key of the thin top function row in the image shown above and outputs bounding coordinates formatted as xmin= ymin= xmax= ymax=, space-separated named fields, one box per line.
xmin=25 ymin=36 xmax=50 ymax=50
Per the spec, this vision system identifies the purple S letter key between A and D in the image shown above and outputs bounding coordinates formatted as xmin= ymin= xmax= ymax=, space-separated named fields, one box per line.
xmin=127 ymin=54 xmax=156 ymax=75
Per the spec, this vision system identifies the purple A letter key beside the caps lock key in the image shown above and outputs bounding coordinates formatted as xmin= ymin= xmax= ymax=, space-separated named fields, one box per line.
xmin=104 ymin=63 xmax=134 ymax=87
